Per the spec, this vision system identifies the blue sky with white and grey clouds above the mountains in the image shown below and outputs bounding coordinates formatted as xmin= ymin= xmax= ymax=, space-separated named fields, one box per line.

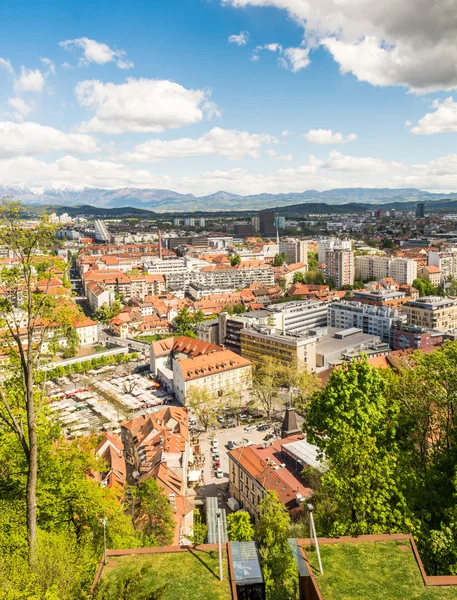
xmin=0 ymin=0 xmax=457 ymax=194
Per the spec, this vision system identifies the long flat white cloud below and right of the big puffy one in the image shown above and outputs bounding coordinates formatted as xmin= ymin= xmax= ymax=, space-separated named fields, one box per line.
xmin=121 ymin=127 xmax=276 ymax=162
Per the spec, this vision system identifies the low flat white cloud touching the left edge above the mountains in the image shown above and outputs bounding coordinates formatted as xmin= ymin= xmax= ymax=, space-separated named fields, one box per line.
xmin=0 ymin=121 xmax=98 ymax=159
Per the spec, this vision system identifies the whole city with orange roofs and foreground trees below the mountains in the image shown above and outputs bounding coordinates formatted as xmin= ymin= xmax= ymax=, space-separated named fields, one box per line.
xmin=4 ymin=198 xmax=457 ymax=600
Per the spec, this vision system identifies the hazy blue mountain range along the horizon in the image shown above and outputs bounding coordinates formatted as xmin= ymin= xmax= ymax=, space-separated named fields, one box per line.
xmin=0 ymin=184 xmax=457 ymax=213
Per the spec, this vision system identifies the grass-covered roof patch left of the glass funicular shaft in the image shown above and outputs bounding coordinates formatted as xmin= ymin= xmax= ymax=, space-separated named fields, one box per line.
xmin=102 ymin=550 xmax=232 ymax=600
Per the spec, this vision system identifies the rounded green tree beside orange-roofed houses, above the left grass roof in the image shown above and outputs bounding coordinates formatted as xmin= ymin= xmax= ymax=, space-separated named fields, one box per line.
xmin=128 ymin=477 xmax=174 ymax=546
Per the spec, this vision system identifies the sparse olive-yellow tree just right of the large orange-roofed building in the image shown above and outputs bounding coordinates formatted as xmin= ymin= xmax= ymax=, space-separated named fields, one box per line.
xmin=252 ymin=356 xmax=289 ymax=417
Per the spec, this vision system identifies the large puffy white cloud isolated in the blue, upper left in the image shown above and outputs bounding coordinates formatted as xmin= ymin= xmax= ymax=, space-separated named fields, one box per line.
xmin=76 ymin=78 xmax=219 ymax=133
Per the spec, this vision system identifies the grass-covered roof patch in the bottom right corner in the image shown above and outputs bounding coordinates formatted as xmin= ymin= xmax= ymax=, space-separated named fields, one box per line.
xmin=305 ymin=540 xmax=457 ymax=600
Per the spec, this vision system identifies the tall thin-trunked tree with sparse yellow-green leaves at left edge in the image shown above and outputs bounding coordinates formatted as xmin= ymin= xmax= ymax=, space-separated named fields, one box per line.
xmin=0 ymin=200 xmax=78 ymax=559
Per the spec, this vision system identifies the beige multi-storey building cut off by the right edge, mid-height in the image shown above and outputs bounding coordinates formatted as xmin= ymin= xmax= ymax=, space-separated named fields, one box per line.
xmin=403 ymin=296 xmax=457 ymax=331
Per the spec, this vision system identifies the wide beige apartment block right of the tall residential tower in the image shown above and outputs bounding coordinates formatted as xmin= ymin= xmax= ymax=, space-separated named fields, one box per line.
xmin=354 ymin=256 xmax=417 ymax=285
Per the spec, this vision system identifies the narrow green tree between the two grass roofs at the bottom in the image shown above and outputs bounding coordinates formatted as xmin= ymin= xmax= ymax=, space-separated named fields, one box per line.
xmin=255 ymin=491 xmax=298 ymax=600
